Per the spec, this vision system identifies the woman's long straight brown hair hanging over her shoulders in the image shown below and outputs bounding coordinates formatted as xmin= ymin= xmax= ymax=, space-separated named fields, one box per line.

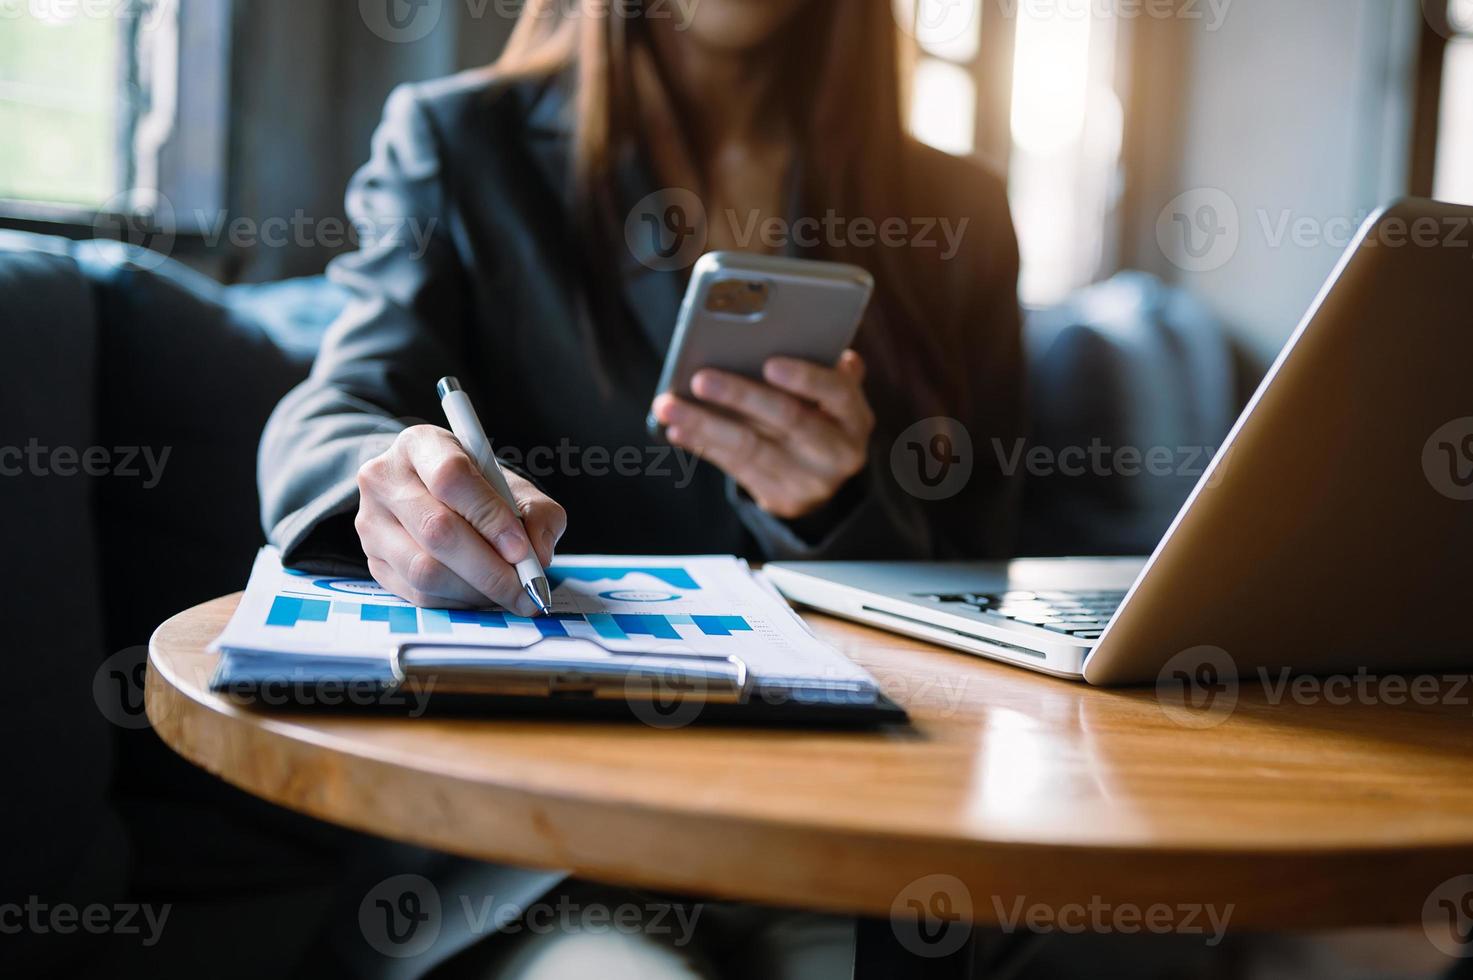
xmin=492 ymin=0 xmax=969 ymax=417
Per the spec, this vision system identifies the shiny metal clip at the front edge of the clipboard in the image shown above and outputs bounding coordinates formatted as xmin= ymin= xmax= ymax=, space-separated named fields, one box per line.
xmin=392 ymin=638 xmax=748 ymax=704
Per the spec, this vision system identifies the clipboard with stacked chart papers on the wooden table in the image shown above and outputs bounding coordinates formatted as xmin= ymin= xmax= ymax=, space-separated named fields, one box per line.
xmin=201 ymin=548 xmax=906 ymax=727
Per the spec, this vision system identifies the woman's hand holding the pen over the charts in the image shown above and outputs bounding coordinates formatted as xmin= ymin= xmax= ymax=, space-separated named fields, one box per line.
xmin=355 ymin=426 xmax=567 ymax=616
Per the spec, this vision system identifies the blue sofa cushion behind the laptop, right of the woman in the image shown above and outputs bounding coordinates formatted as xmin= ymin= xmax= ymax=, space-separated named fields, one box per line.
xmin=1025 ymin=273 xmax=1240 ymax=556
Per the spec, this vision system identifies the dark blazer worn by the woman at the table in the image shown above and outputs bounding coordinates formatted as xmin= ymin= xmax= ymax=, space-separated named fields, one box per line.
xmin=259 ymin=72 xmax=1022 ymax=570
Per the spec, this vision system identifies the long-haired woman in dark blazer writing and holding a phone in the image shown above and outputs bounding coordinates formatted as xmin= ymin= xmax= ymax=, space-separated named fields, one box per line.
xmin=261 ymin=0 xmax=1022 ymax=612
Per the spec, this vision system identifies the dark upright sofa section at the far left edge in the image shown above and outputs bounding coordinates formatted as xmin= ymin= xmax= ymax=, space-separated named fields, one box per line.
xmin=0 ymin=233 xmax=128 ymax=974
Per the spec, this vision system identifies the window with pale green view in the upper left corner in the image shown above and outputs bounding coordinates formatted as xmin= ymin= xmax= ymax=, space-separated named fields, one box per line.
xmin=0 ymin=0 xmax=231 ymax=225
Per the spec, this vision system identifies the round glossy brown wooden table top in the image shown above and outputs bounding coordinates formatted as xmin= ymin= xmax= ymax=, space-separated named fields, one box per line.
xmin=147 ymin=597 xmax=1473 ymax=928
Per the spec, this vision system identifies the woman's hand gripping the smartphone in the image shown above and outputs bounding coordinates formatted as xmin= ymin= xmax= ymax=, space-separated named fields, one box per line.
xmin=654 ymin=351 xmax=875 ymax=520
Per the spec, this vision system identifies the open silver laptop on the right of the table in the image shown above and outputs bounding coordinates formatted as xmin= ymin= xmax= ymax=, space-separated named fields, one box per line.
xmin=766 ymin=199 xmax=1473 ymax=685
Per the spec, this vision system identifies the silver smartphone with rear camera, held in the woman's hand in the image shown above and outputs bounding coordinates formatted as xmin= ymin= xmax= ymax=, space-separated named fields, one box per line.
xmin=648 ymin=252 xmax=875 ymax=439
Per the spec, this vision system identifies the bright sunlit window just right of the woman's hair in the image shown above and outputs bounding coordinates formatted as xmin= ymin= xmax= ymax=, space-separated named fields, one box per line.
xmin=896 ymin=0 xmax=1122 ymax=305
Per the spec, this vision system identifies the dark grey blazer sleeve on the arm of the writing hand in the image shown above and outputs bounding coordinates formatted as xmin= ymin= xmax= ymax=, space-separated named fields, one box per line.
xmin=258 ymin=85 xmax=470 ymax=573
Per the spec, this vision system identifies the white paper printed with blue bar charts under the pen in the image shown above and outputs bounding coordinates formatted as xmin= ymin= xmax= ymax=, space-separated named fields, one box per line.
xmin=212 ymin=548 xmax=878 ymax=694
